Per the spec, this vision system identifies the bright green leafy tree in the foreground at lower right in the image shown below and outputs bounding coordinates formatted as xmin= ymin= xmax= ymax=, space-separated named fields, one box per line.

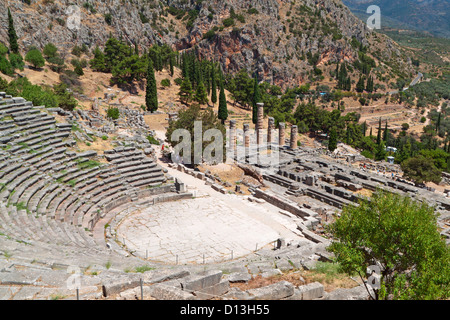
xmin=328 ymin=191 xmax=450 ymax=300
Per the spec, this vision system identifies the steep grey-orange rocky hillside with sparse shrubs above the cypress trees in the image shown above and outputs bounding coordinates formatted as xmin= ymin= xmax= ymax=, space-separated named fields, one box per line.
xmin=0 ymin=0 xmax=412 ymax=87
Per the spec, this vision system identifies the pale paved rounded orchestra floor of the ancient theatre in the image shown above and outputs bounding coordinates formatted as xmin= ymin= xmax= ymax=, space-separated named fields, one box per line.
xmin=117 ymin=197 xmax=299 ymax=264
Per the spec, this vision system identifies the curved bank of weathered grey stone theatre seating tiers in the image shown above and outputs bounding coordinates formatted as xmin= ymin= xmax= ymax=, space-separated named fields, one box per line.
xmin=0 ymin=92 xmax=171 ymax=263
